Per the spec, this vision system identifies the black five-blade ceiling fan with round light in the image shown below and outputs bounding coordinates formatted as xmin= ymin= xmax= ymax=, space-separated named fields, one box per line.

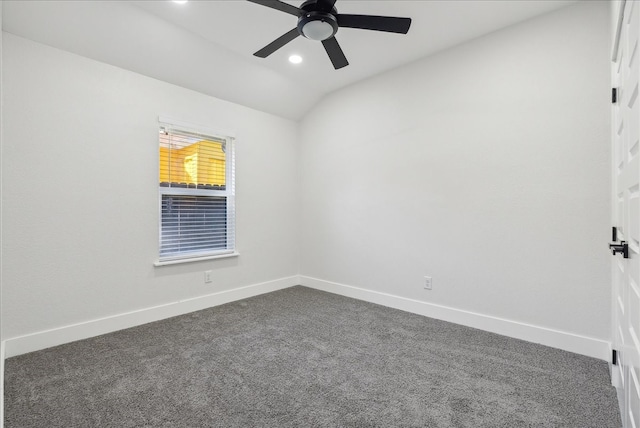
xmin=248 ymin=0 xmax=411 ymax=70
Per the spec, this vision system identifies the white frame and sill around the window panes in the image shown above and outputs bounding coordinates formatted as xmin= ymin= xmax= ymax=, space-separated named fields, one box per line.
xmin=154 ymin=117 xmax=239 ymax=266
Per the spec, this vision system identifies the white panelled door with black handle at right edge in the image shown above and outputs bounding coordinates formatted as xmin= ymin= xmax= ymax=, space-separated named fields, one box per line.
xmin=611 ymin=0 xmax=640 ymax=428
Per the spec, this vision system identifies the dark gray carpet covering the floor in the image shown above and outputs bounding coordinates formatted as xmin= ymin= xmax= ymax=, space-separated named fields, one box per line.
xmin=5 ymin=287 xmax=621 ymax=428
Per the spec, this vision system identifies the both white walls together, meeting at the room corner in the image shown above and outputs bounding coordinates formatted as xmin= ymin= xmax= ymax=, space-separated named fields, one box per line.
xmin=0 ymin=2 xmax=610 ymax=362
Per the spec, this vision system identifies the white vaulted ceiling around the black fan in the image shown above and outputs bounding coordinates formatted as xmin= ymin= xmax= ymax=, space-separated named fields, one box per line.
xmin=2 ymin=0 xmax=576 ymax=120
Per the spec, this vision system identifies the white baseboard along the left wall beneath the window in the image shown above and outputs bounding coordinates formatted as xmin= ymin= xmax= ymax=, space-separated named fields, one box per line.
xmin=3 ymin=275 xmax=300 ymax=361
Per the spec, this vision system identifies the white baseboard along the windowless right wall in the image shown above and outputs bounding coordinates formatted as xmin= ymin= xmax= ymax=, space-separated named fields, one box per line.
xmin=300 ymin=276 xmax=611 ymax=361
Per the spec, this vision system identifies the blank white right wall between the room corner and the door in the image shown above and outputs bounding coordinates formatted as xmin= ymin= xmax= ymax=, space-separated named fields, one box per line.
xmin=300 ymin=2 xmax=611 ymax=340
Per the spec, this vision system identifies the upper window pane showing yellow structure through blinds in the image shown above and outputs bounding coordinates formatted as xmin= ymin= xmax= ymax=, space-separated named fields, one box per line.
xmin=160 ymin=131 xmax=226 ymax=188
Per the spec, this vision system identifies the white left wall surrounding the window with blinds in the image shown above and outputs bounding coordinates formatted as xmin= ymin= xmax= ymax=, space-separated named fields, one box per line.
xmin=2 ymin=33 xmax=298 ymax=339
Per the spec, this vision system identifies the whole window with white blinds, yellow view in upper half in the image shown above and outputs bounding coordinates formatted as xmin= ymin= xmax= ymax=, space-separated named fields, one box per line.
xmin=159 ymin=124 xmax=235 ymax=264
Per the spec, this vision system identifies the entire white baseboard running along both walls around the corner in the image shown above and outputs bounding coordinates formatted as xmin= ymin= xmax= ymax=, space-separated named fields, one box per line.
xmin=0 ymin=275 xmax=611 ymax=362
